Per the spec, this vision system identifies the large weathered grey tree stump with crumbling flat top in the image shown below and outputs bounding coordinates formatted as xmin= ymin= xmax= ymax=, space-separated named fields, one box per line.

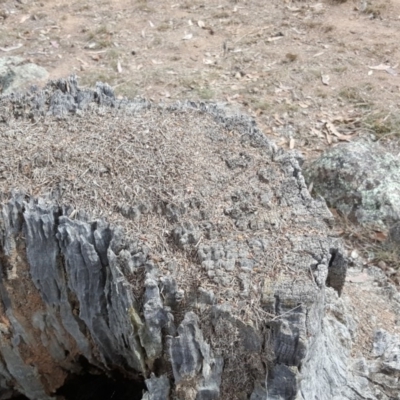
xmin=0 ymin=78 xmax=396 ymax=400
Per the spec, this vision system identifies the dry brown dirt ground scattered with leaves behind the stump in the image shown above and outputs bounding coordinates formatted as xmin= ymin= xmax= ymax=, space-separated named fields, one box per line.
xmin=0 ymin=0 xmax=400 ymax=356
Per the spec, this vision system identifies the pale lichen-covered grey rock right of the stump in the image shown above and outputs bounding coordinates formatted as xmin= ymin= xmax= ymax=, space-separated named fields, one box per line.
xmin=305 ymin=141 xmax=400 ymax=229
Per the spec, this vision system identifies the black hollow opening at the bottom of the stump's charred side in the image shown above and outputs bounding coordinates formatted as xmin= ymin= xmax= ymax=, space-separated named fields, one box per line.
xmin=56 ymin=357 xmax=146 ymax=400
